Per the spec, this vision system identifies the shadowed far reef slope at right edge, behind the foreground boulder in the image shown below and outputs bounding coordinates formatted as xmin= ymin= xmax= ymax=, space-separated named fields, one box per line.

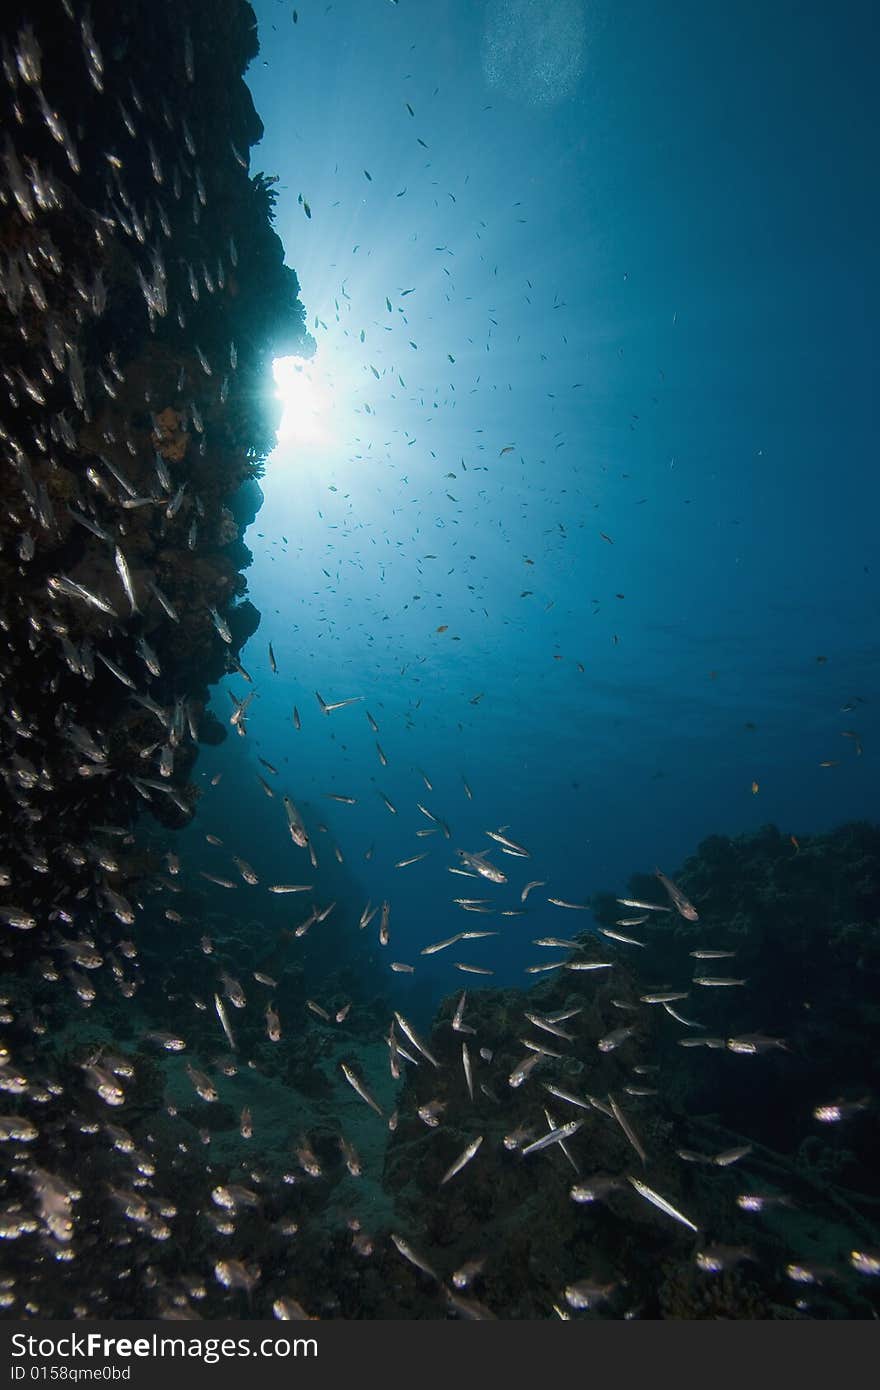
xmin=595 ymin=821 xmax=880 ymax=1173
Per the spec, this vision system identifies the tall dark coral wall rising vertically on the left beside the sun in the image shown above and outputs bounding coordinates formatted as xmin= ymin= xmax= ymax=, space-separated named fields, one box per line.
xmin=0 ymin=0 xmax=311 ymax=956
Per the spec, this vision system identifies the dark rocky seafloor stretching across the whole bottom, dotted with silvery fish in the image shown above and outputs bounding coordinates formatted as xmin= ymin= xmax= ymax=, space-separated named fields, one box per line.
xmin=3 ymin=824 xmax=880 ymax=1319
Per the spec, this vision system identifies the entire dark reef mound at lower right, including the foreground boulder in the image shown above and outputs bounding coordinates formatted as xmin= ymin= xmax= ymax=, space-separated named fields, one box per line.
xmin=375 ymin=824 xmax=880 ymax=1319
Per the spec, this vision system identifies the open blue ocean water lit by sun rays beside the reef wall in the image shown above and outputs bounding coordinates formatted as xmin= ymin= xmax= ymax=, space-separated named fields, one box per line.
xmin=193 ymin=0 xmax=877 ymax=1006
